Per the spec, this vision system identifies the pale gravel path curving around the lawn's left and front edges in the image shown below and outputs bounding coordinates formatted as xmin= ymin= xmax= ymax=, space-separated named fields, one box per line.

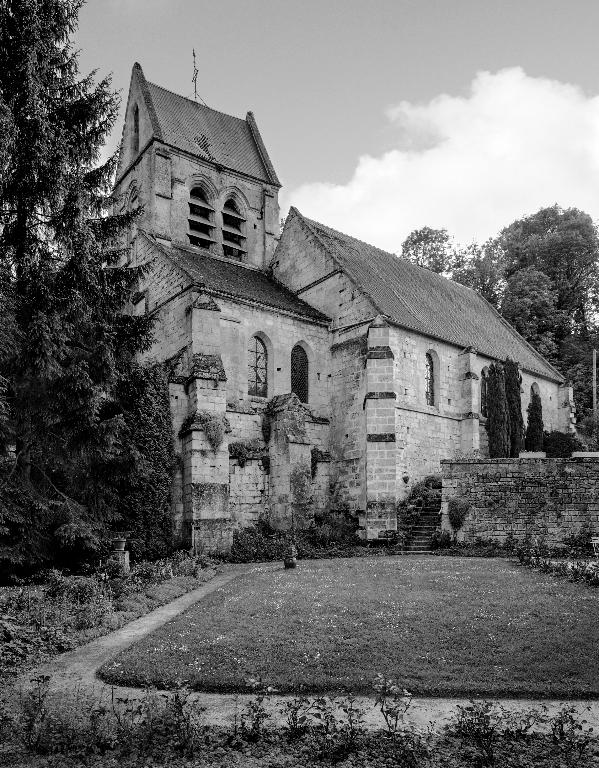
xmin=12 ymin=564 xmax=599 ymax=730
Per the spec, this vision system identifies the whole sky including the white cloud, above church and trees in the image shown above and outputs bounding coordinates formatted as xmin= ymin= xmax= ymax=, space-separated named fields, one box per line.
xmin=75 ymin=0 xmax=599 ymax=252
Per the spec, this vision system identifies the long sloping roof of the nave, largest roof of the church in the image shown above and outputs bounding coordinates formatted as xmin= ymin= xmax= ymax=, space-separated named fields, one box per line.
xmin=290 ymin=207 xmax=564 ymax=381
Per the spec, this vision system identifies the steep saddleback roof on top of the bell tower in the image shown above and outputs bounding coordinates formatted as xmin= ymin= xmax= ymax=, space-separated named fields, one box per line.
xmin=122 ymin=62 xmax=281 ymax=187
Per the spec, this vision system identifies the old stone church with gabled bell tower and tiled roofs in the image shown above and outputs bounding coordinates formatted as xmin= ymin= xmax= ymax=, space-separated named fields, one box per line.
xmin=115 ymin=64 xmax=574 ymax=551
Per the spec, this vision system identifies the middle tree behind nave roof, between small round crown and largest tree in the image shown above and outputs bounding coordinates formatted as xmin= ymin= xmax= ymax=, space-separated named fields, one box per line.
xmin=451 ymin=239 xmax=505 ymax=308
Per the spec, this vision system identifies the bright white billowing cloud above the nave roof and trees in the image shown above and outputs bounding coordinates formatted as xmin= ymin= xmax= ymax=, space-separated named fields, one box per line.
xmin=283 ymin=67 xmax=599 ymax=252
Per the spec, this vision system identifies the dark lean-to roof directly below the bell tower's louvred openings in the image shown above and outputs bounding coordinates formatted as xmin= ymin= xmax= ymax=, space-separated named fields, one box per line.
xmin=140 ymin=232 xmax=330 ymax=324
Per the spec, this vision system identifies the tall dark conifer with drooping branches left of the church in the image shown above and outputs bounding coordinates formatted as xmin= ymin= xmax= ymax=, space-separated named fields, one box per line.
xmin=0 ymin=0 xmax=151 ymax=564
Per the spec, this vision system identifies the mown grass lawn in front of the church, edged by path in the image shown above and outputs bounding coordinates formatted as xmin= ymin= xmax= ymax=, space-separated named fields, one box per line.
xmin=101 ymin=557 xmax=599 ymax=698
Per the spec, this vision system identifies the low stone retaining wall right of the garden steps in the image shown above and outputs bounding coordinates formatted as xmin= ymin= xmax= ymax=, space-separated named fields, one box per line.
xmin=441 ymin=457 xmax=599 ymax=546
